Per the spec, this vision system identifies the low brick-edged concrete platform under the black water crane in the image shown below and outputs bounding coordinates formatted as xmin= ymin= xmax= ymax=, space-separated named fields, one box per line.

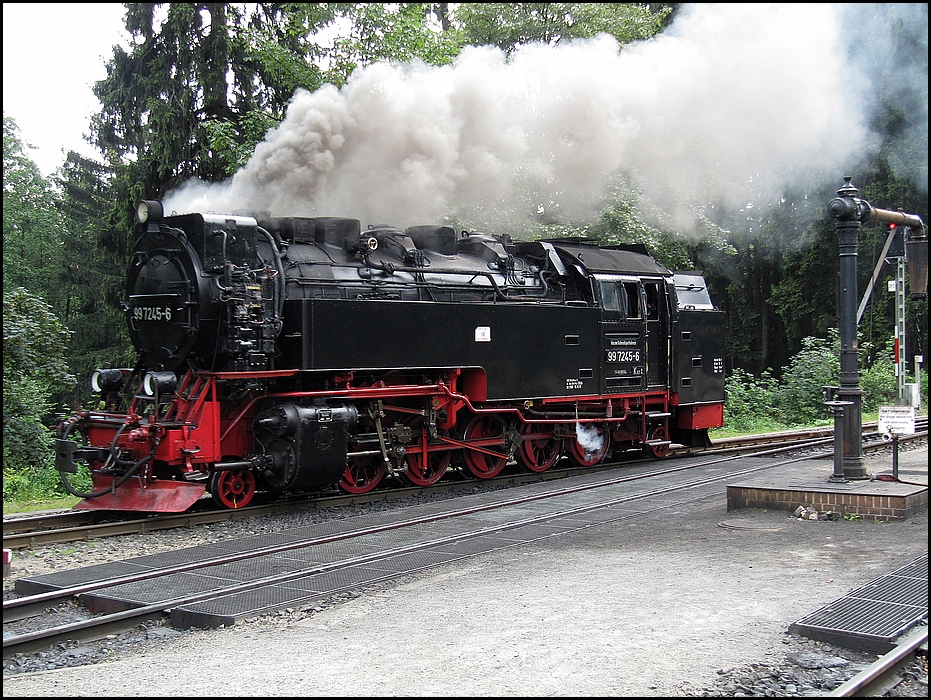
xmin=727 ymin=444 xmax=928 ymax=520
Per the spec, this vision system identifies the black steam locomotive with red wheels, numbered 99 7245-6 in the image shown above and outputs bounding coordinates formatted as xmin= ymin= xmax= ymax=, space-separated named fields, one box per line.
xmin=56 ymin=201 xmax=724 ymax=512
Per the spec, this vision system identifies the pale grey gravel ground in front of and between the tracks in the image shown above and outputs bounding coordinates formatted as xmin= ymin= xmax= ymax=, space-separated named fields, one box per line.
xmin=4 ymin=443 xmax=928 ymax=697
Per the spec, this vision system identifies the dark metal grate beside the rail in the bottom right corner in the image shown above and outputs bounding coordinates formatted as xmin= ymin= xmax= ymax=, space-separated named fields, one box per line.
xmin=789 ymin=554 xmax=928 ymax=654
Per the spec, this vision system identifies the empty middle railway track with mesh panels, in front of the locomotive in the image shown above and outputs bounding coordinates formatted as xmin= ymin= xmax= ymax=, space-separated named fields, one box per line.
xmin=3 ymin=438 xmax=924 ymax=658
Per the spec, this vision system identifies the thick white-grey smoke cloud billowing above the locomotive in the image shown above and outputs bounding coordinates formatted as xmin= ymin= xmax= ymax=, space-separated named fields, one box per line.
xmin=166 ymin=4 xmax=927 ymax=232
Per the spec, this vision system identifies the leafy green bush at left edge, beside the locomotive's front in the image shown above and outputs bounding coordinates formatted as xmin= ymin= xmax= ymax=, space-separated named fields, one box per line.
xmin=3 ymin=287 xmax=74 ymax=499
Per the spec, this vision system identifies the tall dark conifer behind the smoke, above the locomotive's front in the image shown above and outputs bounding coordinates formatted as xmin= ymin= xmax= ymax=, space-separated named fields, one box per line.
xmin=92 ymin=3 xmax=356 ymax=203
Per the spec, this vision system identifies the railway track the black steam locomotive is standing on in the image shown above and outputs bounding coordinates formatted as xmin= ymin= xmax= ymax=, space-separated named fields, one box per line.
xmin=3 ymin=418 xmax=927 ymax=550
